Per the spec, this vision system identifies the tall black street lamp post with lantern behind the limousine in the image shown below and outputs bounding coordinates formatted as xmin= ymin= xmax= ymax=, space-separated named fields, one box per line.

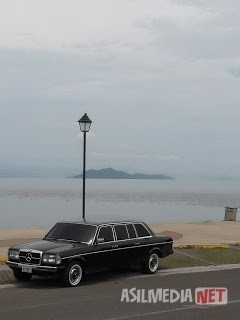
xmin=78 ymin=113 xmax=92 ymax=221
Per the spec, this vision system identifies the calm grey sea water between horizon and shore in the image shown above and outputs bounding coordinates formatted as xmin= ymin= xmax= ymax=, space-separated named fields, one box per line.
xmin=0 ymin=178 xmax=240 ymax=228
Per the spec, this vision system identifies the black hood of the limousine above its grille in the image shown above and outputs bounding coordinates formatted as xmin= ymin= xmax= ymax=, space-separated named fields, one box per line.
xmin=11 ymin=240 xmax=87 ymax=253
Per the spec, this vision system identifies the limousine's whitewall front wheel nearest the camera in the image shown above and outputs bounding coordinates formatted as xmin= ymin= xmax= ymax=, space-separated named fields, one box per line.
xmin=61 ymin=261 xmax=83 ymax=287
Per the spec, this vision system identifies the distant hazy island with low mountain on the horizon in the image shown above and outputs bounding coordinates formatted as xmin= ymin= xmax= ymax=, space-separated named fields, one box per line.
xmin=72 ymin=168 xmax=174 ymax=180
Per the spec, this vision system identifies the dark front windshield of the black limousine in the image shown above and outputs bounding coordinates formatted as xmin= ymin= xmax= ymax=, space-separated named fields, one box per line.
xmin=44 ymin=223 xmax=97 ymax=243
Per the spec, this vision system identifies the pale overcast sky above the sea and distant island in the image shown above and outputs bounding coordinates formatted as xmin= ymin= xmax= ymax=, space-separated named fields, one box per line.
xmin=0 ymin=0 xmax=240 ymax=177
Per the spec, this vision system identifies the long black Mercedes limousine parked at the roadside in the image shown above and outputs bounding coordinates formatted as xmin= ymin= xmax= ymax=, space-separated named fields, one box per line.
xmin=6 ymin=221 xmax=173 ymax=287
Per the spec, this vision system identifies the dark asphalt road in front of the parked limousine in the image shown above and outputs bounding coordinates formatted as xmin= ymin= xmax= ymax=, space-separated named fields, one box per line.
xmin=0 ymin=269 xmax=240 ymax=320
